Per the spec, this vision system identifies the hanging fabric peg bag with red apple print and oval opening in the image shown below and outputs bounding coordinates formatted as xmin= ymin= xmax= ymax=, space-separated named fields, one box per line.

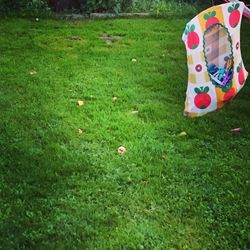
xmin=182 ymin=1 xmax=250 ymax=117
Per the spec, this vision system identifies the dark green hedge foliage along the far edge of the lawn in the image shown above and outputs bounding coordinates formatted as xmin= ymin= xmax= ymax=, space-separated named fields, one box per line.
xmin=0 ymin=0 xmax=238 ymax=14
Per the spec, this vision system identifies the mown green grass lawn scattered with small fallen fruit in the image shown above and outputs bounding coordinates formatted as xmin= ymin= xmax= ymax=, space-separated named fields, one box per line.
xmin=0 ymin=18 xmax=250 ymax=250
